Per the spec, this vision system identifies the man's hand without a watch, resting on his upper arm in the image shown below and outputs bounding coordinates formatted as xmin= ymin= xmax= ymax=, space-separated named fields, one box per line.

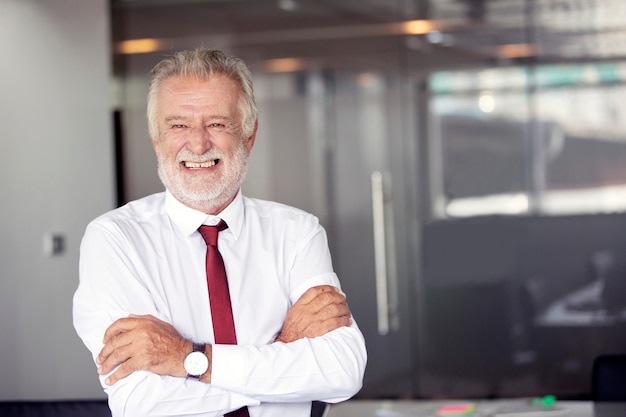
xmin=276 ymin=285 xmax=352 ymax=343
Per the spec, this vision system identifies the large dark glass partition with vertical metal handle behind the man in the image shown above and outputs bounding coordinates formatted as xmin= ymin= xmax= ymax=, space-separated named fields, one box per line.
xmin=111 ymin=0 xmax=626 ymax=398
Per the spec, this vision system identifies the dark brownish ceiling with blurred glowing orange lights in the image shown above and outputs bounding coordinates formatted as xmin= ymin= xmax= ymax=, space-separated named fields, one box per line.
xmin=112 ymin=0 xmax=626 ymax=71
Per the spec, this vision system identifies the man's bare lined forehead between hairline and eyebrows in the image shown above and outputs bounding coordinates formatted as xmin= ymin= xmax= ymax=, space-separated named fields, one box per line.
xmin=158 ymin=74 xmax=241 ymax=115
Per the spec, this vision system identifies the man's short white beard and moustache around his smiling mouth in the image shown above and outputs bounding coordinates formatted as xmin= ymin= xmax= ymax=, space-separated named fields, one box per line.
xmin=157 ymin=140 xmax=248 ymax=214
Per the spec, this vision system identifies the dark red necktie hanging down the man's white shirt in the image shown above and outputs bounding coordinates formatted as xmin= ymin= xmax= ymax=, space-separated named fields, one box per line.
xmin=198 ymin=220 xmax=249 ymax=417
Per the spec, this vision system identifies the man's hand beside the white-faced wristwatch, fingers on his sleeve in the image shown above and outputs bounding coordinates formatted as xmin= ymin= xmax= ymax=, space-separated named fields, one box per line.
xmin=96 ymin=314 xmax=191 ymax=385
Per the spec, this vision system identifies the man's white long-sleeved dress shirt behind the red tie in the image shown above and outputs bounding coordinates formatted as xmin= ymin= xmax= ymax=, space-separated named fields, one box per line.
xmin=73 ymin=192 xmax=367 ymax=417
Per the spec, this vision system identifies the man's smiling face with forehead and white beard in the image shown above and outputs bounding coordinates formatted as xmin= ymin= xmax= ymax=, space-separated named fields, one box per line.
xmin=152 ymin=74 xmax=256 ymax=214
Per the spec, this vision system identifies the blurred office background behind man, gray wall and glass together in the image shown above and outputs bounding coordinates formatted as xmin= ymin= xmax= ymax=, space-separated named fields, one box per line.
xmin=0 ymin=0 xmax=626 ymax=400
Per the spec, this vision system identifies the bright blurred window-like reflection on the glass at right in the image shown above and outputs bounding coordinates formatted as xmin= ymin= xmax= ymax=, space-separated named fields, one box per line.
xmin=429 ymin=62 xmax=626 ymax=217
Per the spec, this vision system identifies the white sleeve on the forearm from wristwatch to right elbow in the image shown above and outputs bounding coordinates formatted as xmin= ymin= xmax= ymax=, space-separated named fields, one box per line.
xmin=212 ymin=324 xmax=366 ymax=403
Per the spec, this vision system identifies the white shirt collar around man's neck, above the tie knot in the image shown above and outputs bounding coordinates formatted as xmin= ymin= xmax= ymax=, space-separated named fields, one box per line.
xmin=165 ymin=189 xmax=244 ymax=239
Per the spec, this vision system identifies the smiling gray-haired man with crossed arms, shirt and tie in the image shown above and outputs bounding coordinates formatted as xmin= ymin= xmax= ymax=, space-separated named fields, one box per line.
xmin=74 ymin=49 xmax=366 ymax=417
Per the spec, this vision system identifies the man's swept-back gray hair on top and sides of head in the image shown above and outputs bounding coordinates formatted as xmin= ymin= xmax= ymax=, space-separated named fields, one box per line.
xmin=148 ymin=48 xmax=258 ymax=139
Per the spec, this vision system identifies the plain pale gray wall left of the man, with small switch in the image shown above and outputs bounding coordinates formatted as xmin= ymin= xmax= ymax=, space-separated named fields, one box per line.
xmin=0 ymin=0 xmax=114 ymax=400
